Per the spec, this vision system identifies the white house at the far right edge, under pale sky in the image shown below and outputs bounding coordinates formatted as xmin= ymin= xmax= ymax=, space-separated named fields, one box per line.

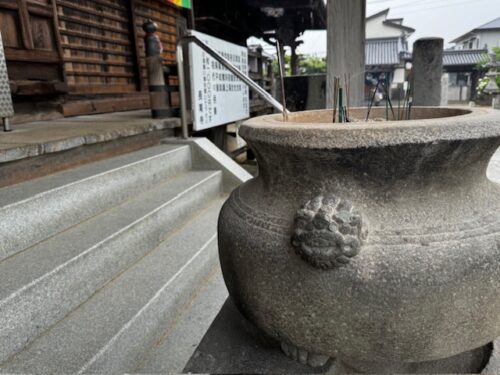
xmin=451 ymin=17 xmax=500 ymax=52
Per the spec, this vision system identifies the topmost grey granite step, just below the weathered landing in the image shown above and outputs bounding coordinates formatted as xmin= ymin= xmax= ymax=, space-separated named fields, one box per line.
xmin=0 ymin=145 xmax=192 ymax=260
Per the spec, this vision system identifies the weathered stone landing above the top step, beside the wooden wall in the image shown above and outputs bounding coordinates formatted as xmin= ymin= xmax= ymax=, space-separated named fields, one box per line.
xmin=0 ymin=110 xmax=180 ymax=187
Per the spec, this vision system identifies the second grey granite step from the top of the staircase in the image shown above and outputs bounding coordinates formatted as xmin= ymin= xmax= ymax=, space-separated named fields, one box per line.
xmin=0 ymin=166 xmax=222 ymax=363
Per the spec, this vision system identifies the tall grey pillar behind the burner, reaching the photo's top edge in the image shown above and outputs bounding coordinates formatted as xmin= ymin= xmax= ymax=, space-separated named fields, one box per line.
xmin=326 ymin=0 xmax=366 ymax=108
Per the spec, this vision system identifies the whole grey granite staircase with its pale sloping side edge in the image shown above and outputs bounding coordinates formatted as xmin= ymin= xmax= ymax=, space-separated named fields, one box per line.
xmin=0 ymin=139 xmax=249 ymax=374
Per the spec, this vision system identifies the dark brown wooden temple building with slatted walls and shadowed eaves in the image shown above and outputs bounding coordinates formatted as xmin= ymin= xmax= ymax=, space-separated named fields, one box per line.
xmin=0 ymin=0 xmax=326 ymax=123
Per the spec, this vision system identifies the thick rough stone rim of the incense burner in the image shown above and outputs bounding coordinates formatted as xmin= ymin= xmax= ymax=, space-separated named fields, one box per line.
xmin=240 ymin=107 xmax=500 ymax=149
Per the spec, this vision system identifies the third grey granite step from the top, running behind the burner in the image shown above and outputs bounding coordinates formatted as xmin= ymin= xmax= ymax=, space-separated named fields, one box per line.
xmin=0 ymin=198 xmax=227 ymax=374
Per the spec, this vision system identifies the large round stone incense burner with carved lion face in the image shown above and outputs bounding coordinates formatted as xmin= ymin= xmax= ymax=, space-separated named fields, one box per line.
xmin=219 ymin=108 xmax=500 ymax=372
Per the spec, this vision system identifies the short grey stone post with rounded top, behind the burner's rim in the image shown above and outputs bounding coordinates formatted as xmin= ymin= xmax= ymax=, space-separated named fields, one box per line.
xmin=413 ymin=38 xmax=444 ymax=106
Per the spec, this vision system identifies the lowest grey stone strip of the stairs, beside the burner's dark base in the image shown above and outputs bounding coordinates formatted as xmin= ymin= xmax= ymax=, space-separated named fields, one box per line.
xmin=138 ymin=269 xmax=228 ymax=374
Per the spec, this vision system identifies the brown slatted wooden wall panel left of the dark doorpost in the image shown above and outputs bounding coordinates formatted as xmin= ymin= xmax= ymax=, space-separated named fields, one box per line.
xmin=57 ymin=0 xmax=138 ymax=94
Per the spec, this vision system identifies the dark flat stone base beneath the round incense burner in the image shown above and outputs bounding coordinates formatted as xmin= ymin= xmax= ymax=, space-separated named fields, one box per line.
xmin=183 ymin=299 xmax=500 ymax=374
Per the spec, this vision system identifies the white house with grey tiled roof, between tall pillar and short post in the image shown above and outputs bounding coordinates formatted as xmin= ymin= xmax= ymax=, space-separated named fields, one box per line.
xmin=365 ymin=8 xmax=415 ymax=101
